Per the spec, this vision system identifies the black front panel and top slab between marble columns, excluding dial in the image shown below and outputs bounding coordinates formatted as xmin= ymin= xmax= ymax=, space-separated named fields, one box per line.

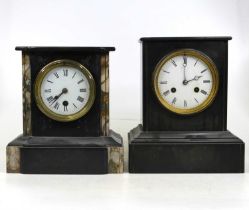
xmin=16 ymin=47 xmax=115 ymax=137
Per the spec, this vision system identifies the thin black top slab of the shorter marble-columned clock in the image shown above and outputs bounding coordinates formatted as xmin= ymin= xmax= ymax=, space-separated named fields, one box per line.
xmin=15 ymin=46 xmax=115 ymax=53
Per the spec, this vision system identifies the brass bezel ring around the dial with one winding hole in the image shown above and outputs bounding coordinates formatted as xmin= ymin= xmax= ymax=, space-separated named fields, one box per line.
xmin=34 ymin=59 xmax=96 ymax=122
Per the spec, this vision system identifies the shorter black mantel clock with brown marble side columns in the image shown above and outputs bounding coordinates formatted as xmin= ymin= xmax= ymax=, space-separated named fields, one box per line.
xmin=7 ymin=47 xmax=123 ymax=174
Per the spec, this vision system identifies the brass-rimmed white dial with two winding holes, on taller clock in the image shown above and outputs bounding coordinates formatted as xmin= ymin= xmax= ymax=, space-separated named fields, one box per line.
xmin=152 ymin=49 xmax=219 ymax=115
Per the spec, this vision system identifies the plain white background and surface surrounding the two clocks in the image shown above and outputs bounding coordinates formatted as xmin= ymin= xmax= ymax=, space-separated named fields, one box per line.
xmin=0 ymin=0 xmax=249 ymax=210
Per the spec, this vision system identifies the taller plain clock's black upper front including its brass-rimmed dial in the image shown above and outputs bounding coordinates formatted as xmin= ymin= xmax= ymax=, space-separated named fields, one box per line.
xmin=142 ymin=38 xmax=228 ymax=131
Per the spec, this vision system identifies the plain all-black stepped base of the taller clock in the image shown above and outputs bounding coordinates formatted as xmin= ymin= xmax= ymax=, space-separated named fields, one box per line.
xmin=128 ymin=125 xmax=245 ymax=173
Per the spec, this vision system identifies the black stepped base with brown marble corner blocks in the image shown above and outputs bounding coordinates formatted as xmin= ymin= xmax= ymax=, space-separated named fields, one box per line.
xmin=7 ymin=131 xmax=123 ymax=174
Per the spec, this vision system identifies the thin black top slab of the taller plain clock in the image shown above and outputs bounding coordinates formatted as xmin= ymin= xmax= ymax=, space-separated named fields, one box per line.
xmin=140 ymin=36 xmax=232 ymax=42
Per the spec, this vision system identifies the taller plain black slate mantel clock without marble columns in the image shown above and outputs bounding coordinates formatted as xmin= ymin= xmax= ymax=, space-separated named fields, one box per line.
xmin=129 ymin=37 xmax=244 ymax=173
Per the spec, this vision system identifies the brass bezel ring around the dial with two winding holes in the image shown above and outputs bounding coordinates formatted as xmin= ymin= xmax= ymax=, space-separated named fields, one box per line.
xmin=152 ymin=49 xmax=219 ymax=115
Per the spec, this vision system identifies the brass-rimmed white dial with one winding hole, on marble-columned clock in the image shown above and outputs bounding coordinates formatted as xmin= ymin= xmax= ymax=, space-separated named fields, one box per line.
xmin=34 ymin=59 xmax=96 ymax=122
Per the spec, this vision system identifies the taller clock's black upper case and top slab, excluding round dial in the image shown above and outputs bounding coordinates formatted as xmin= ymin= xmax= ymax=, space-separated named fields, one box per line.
xmin=142 ymin=37 xmax=231 ymax=132
